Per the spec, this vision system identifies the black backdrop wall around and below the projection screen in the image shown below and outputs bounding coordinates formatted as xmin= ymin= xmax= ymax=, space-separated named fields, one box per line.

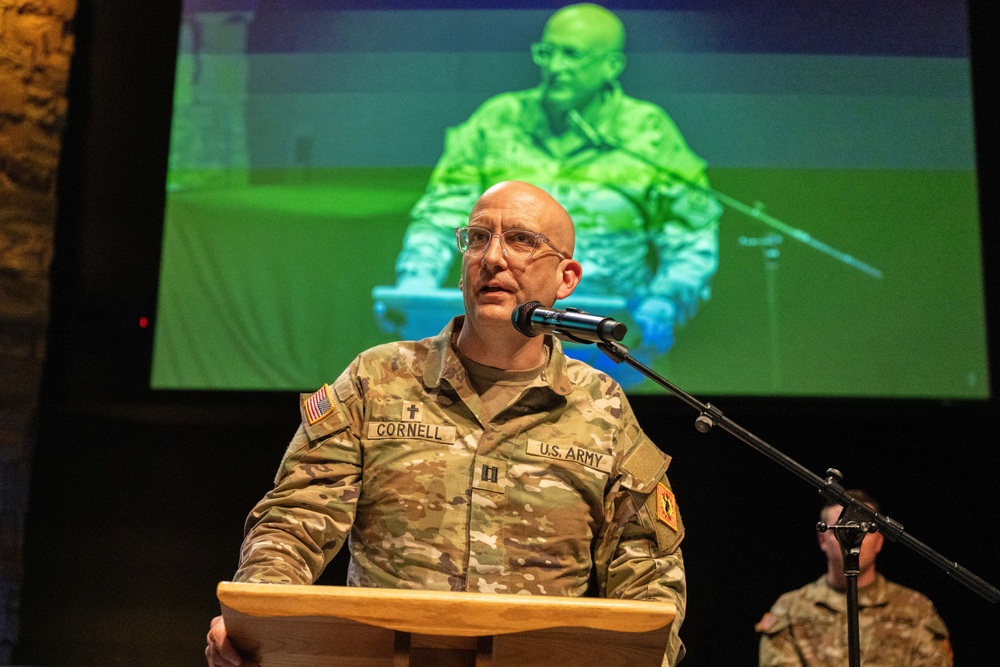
xmin=15 ymin=0 xmax=1000 ymax=667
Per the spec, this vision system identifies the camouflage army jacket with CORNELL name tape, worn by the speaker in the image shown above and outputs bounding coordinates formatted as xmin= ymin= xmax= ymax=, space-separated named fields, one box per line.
xmin=236 ymin=317 xmax=686 ymax=665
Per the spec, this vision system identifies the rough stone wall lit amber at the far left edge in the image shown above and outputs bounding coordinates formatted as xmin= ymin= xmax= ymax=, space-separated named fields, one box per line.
xmin=0 ymin=0 xmax=76 ymax=664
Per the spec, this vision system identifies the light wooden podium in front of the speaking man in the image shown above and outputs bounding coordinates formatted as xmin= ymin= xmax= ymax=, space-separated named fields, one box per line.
xmin=218 ymin=582 xmax=676 ymax=667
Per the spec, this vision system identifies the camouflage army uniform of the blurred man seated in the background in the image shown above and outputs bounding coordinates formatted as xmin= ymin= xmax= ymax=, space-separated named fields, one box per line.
xmin=756 ymin=575 xmax=952 ymax=667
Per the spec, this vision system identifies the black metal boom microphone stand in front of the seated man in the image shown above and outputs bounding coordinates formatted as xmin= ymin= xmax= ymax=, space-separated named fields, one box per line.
xmin=583 ymin=341 xmax=1000 ymax=667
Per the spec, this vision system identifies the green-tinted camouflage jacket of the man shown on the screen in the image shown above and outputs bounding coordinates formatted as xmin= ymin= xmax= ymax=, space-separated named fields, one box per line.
xmin=396 ymin=85 xmax=722 ymax=312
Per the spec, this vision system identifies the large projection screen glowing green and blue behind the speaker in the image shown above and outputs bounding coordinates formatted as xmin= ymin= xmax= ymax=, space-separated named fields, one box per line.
xmin=152 ymin=0 xmax=989 ymax=398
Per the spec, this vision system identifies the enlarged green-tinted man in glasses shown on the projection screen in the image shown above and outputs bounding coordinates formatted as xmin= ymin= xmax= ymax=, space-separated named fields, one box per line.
xmin=386 ymin=4 xmax=722 ymax=384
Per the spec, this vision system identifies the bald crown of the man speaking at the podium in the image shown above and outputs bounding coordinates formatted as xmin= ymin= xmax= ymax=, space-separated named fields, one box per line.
xmin=469 ymin=181 xmax=576 ymax=257
